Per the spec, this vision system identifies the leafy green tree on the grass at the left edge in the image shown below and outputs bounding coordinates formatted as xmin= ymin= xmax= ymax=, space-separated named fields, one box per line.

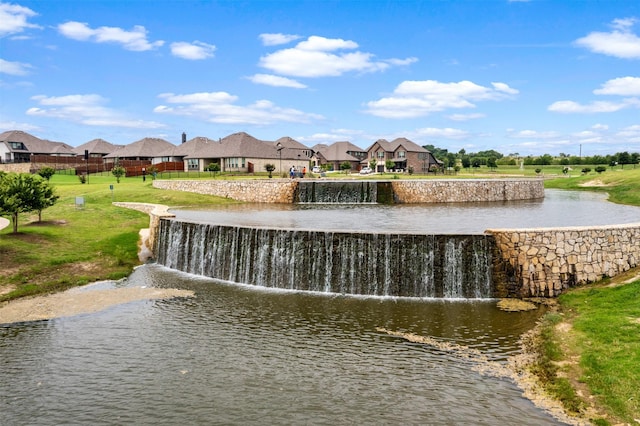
xmin=0 ymin=173 xmax=58 ymax=234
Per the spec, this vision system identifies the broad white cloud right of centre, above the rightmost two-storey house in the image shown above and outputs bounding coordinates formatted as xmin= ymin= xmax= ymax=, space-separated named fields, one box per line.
xmin=365 ymin=80 xmax=518 ymax=118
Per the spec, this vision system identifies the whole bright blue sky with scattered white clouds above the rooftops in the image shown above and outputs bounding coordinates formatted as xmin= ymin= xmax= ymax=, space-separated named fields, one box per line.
xmin=0 ymin=0 xmax=640 ymax=156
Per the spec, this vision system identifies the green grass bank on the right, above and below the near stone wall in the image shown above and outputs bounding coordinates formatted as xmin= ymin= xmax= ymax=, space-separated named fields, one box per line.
xmin=533 ymin=168 xmax=640 ymax=425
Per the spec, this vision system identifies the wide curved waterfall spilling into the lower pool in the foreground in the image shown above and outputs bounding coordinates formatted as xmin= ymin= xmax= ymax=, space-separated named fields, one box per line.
xmin=157 ymin=219 xmax=493 ymax=298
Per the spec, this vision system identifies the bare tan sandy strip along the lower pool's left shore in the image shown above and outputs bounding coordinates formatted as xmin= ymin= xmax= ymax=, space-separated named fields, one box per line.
xmin=0 ymin=286 xmax=193 ymax=324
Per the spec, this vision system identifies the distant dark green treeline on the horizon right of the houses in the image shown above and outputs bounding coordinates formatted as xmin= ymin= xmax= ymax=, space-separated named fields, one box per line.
xmin=423 ymin=145 xmax=640 ymax=168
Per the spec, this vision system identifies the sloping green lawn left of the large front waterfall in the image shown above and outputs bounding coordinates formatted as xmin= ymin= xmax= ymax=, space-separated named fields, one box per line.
xmin=0 ymin=175 xmax=236 ymax=302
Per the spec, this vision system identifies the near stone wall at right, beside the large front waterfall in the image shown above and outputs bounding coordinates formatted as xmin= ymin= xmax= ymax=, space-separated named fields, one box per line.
xmin=486 ymin=223 xmax=640 ymax=297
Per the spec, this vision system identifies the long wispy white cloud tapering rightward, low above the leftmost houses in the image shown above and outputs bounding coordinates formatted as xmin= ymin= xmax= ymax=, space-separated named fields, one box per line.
xmin=27 ymin=94 xmax=164 ymax=129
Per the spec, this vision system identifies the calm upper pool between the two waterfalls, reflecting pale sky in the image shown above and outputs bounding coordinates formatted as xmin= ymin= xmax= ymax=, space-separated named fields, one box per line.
xmin=172 ymin=189 xmax=640 ymax=234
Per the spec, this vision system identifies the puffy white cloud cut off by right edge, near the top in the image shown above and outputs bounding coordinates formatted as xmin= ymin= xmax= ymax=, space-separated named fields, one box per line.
xmin=575 ymin=18 xmax=640 ymax=59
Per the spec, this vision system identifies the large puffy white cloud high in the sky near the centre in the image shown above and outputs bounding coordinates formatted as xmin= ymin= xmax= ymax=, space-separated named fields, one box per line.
xmin=259 ymin=36 xmax=416 ymax=77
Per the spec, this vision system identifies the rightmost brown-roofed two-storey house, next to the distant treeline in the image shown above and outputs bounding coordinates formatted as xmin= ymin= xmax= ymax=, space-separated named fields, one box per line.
xmin=364 ymin=138 xmax=442 ymax=173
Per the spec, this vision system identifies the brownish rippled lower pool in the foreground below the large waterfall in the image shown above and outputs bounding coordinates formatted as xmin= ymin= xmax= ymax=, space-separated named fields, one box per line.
xmin=0 ymin=265 xmax=558 ymax=425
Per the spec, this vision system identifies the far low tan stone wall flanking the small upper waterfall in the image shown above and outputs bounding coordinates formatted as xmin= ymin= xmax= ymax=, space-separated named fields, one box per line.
xmin=153 ymin=179 xmax=544 ymax=204
